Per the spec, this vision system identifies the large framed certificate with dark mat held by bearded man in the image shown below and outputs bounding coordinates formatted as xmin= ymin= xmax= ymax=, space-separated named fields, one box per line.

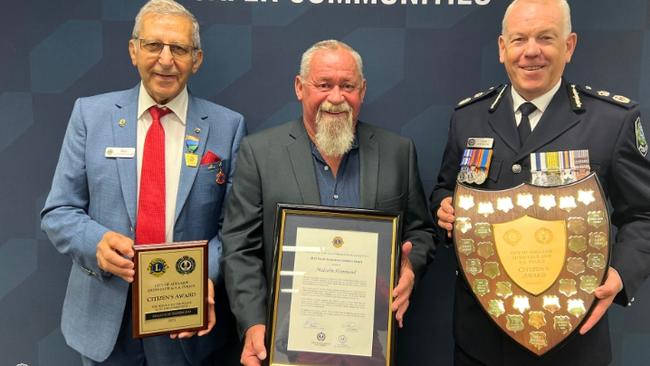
xmin=266 ymin=204 xmax=401 ymax=366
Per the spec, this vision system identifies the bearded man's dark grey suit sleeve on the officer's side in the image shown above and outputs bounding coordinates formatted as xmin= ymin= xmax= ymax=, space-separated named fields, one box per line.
xmin=403 ymin=141 xmax=435 ymax=280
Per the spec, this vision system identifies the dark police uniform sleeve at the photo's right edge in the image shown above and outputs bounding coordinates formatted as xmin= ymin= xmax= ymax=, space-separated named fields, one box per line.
xmin=609 ymin=108 xmax=650 ymax=305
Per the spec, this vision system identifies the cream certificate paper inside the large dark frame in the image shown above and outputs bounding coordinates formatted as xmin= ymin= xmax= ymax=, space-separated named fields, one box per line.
xmin=288 ymin=228 xmax=379 ymax=357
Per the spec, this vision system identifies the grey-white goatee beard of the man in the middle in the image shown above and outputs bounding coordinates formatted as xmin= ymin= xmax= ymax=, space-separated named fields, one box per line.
xmin=315 ymin=101 xmax=354 ymax=157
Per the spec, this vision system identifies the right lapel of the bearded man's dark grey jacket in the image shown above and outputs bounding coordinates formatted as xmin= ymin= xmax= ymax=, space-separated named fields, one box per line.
xmin=357 ymin=122 xmax=379 ymax=208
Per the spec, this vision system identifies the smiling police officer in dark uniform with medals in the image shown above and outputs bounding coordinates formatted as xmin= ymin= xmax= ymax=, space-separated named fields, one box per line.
xmin=431 ymin=0 xmax=650 ymax=366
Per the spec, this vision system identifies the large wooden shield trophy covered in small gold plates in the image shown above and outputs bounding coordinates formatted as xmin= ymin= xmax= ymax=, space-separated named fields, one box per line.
xmin=454 ymin=174 xmax=610 ymax=356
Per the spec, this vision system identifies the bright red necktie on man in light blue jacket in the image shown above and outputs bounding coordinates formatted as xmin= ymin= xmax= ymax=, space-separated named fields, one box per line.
xmin=135 ymin=106 xmax=171 ymax=244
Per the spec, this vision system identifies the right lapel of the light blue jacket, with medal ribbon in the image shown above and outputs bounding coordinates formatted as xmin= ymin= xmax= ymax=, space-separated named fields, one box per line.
xmin=174 ymin=94 xmax=210 ymax=222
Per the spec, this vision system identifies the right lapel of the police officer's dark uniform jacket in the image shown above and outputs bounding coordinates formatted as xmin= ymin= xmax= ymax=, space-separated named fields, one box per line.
xmin=515 ymin=82 xmax=580 ymax=160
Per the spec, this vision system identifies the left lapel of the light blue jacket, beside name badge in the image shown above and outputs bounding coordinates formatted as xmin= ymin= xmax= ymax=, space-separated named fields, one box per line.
xmin=110 ymin=84 xmax=140 ymax=227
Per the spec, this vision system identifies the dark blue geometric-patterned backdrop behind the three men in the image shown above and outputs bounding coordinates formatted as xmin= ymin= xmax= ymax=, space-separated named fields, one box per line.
xmin=0 ymin=0 xmax=650 ymax=366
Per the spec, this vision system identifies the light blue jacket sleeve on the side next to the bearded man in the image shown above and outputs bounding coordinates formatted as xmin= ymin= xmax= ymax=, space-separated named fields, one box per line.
xmin=208 ymin=114 xmax=246 ymax=283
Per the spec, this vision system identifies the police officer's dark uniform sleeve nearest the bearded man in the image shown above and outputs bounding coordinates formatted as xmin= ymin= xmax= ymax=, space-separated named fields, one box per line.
xmin=430 ymin=114 xmax=462 ymax=244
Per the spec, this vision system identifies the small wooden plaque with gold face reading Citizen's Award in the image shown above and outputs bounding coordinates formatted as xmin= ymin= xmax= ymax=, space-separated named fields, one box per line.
xmin=131 ymin=240 xmax=208 ymax=338
